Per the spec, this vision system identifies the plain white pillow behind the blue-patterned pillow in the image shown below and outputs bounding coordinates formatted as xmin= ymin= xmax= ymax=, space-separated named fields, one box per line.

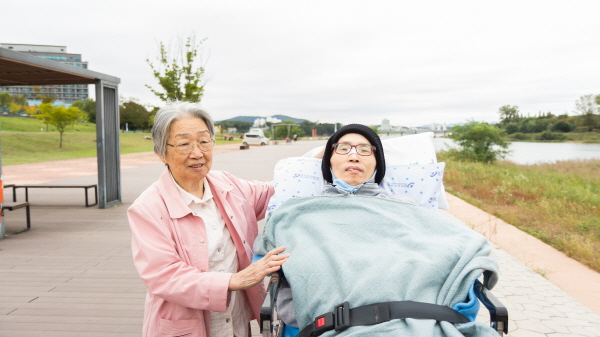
xmin=302 ymin=132 xmax=449 ymax=209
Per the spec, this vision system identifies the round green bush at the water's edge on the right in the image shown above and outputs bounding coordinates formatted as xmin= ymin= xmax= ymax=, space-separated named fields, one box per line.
xmin=445 ymin=121 xmax=509 ymax=163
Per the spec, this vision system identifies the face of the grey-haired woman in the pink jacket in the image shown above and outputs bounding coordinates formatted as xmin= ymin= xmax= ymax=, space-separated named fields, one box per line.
xmin=161 ymin=116 xmax=213 ymax=187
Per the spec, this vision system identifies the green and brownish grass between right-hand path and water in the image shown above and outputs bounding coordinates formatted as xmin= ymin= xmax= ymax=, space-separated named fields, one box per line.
xmin=441 ymin=154 xmax=600 ymax=271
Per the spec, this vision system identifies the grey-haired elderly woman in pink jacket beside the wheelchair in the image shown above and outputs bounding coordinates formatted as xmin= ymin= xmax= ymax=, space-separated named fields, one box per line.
xmin=127 ymin=102 xmax=289 ymax=337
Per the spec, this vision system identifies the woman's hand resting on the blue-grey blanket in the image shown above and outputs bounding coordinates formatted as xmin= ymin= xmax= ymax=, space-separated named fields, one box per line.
xmin=229 ymin=246 xmax=290 ymax=291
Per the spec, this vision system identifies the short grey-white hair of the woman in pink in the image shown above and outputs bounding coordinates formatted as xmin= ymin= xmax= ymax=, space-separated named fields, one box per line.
xmin=152 ymin=101 xmax=215 ymax=158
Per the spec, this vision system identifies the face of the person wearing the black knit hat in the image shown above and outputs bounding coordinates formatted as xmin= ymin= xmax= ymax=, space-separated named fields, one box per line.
xmin=329 ymin=133 xmax=379 ymax=185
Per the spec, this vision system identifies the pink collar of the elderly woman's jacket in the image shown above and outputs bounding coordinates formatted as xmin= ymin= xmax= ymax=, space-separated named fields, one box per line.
xmin=157 ymin=168 xmax=233 ymax=219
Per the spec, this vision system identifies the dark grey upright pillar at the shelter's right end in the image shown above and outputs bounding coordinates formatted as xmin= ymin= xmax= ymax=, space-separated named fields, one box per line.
xmin=96 ymin=79 xmax=121 ymax=208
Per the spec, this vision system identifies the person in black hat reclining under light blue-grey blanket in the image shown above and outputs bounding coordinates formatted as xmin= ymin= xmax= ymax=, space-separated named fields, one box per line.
xmin=254 ymin=124 xmax=498 ymax=337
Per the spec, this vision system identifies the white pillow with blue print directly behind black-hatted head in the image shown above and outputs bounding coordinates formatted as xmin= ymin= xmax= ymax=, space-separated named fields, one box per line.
xmin=267 ymin=157 xmax=445 ymax=213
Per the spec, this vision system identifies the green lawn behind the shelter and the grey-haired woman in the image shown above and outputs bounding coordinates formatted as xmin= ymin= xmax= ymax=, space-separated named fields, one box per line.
xmin=0 ymin=117 xmax=241 ymax=165
